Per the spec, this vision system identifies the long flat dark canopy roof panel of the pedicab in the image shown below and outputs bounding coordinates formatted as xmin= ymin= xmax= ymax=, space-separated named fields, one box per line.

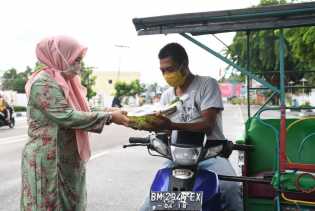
xmin=133 ymin=2 xmax=315 ymax=35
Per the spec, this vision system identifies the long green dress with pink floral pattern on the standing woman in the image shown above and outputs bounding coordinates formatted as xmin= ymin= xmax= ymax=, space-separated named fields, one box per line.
xmin=21 ymin=72 xmax=109 ymax=211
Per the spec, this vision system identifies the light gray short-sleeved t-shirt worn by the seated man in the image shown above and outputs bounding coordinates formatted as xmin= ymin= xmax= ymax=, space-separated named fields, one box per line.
xmin=160 ymin=75 xmax=225 ymax=143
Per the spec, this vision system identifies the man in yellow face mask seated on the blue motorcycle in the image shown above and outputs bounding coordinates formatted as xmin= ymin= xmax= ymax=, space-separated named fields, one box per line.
xmin=142 ymin=43 xmax=243 ymax=211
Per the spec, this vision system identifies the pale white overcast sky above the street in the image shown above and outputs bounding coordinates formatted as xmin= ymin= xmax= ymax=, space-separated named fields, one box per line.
xmin=0 ymin=0 xmax=259 ymax=85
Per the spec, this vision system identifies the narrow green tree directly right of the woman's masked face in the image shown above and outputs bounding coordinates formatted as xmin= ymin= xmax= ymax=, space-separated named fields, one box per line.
xmin=81 ymin=62 xmax=96 ymax=99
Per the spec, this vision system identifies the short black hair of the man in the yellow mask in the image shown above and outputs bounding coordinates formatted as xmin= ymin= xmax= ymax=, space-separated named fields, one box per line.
xmin=159 ymin=43 xmax=188 ymax=66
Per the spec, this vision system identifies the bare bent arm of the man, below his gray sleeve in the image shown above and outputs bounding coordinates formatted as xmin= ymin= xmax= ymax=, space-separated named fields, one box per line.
xmin=169 ymin=108 xmax=220 ymax=132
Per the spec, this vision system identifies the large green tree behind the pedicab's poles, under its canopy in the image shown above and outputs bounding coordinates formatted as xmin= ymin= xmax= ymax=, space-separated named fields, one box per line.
xmin=226 ymin=0 xmax=315 ymax=85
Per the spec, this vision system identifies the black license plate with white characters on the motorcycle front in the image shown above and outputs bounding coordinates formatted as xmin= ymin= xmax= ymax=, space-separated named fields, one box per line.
xmin=150 ymin=191 xmax=202 ymax=211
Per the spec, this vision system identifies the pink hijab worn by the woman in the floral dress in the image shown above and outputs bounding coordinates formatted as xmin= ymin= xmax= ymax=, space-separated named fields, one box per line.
xmin=25 ymin=36 xmax=91 ymax=161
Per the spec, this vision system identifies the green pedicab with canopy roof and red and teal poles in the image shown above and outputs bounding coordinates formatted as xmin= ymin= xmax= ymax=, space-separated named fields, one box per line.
xmin=133 ymin=2 xmax=315 ymax=211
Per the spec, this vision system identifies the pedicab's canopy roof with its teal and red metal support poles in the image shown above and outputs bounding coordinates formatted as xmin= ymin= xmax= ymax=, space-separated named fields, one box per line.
xmin=133 ymin=2 xmax=315 ymax=210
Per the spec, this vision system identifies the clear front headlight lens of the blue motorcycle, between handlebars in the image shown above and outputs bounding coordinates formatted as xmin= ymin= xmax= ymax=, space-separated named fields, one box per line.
xmin=171 ymin=146 xmax=201 ymax=166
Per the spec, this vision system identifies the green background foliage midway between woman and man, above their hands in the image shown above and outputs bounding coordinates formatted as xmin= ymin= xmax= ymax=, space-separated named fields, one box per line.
xmin=115 ymin=80 xmax=145 ymax=97
